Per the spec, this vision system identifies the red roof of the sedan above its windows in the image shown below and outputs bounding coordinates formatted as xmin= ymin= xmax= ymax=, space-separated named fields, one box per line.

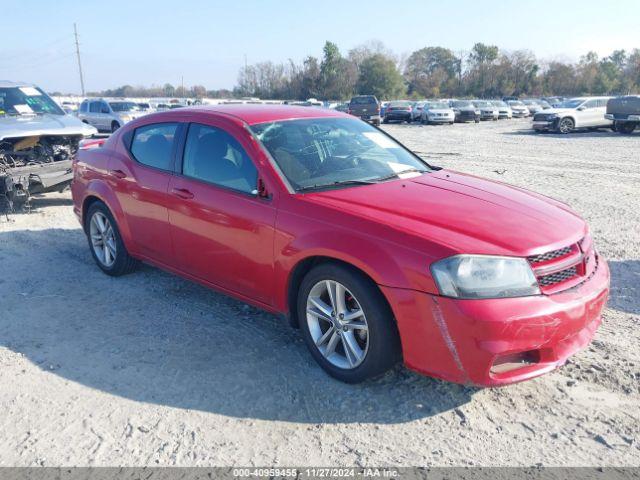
xmin=162 ymin=104 xmax=353 ymax=125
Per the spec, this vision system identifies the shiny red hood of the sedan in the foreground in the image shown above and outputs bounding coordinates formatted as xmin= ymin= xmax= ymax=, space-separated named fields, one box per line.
xmin=306 ymin=170 xmax=587 ymax=256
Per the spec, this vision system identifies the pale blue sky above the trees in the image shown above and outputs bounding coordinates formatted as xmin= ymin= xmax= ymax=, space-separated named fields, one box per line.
xmin=0 ymin=0 xmax=640 ymax=93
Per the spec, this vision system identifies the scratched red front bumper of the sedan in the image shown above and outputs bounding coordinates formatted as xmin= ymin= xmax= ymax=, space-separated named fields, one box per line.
xmin=381 ymin=255 xmax=609 ymax=386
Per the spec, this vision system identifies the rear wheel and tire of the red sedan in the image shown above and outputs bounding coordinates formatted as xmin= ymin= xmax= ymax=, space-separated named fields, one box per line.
xmin=85 ymin=202 xmax=138 ymax=277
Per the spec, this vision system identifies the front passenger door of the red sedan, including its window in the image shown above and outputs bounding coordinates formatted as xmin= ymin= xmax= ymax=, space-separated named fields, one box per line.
xmin=169 ymin=119 xmax=276 ymax=304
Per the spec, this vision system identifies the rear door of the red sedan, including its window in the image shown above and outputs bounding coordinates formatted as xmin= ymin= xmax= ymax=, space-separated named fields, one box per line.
xmin=109 ymin=122 xmax=183 ymax=266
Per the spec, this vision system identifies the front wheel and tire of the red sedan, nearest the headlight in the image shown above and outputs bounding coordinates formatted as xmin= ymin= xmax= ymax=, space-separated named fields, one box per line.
xmin=297 ymin=263 xmax=402 ymax=383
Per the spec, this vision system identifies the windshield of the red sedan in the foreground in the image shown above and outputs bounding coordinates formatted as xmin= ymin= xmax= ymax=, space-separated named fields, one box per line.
xmin=251 ymin=118 xmax=429 ymax=190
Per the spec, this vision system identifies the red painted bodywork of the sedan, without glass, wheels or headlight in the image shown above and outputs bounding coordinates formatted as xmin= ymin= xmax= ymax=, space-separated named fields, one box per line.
xmin=72 ymin=105 xmax=609 ymax=385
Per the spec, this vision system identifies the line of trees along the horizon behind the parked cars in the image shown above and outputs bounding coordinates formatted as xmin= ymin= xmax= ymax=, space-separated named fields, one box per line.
xmin=82 ymin=41 xmax=640 ymax=100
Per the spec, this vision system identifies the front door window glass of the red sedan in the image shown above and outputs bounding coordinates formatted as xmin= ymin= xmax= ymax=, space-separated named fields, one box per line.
xmin=182 ymin=123 xmax=258 ymax=193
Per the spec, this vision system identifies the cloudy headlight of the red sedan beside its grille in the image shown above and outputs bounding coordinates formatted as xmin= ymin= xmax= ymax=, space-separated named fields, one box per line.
xmin=431 ymin=255 xmax=540 ymax=298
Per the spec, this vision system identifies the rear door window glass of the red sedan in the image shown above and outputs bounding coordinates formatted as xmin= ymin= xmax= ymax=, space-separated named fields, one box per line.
xmin=131 ymin=123 xmax=178 ymax=170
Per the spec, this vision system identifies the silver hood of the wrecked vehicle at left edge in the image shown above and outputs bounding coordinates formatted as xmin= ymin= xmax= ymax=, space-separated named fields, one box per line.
xmin=0 ymin=113 xmax=98 ymax=139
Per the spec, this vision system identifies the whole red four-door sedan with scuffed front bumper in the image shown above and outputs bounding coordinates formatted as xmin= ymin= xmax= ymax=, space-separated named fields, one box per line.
xmin=72 ymin=106 xmax=609 ymax=385
